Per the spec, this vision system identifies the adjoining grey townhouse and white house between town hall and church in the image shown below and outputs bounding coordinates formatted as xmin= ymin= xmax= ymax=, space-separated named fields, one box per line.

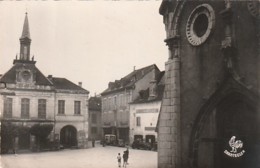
xmin=101 ymin=64 xmax=164 ymax=144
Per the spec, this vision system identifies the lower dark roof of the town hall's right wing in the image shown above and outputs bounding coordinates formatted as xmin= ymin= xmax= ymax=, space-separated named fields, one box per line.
xmin=49 ymin=77 xmax=89 ymax=93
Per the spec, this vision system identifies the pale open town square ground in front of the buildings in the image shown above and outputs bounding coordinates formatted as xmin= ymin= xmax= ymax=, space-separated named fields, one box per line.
xmin=0 ymin=145 xmax=157 ymax=168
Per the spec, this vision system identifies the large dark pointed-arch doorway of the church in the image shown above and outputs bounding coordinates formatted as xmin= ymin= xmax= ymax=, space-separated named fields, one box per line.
xmin=190 ymin=82 xmax=260 ymax=168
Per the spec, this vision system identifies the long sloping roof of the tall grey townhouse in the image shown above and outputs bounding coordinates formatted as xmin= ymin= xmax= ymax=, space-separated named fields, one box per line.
xmin=101 ymin=64 xmax=158 ymax=95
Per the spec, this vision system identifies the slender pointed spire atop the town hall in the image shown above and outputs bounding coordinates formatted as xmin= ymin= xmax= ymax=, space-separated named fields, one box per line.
xmin=20 ymin=12 xmax=31 ymax=61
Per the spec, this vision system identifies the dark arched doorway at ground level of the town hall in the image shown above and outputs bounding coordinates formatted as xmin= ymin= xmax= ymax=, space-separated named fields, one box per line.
xmin=60 ymin=125 xmax=77 ymax=148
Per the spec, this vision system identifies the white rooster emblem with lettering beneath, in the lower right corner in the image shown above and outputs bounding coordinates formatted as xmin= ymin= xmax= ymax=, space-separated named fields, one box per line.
xmin=224 ymin=136 xmax=245 ymax=158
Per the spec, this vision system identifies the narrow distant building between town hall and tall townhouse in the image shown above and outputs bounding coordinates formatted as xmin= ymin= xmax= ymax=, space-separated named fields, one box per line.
xmin=88 ymin=96 xmax=102 ymax=140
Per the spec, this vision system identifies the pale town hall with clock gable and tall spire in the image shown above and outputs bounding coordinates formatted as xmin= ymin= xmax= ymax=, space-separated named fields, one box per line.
xmin=0 ymin=13 xmax=89 ymax=153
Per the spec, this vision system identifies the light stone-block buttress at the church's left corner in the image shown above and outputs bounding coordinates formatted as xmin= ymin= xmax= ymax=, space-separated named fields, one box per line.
xmin=158 ymin=58 xmax=180 ymax=168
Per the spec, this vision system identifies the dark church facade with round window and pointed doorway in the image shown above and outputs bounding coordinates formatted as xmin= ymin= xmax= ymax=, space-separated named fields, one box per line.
xmin=158 ymin=0 xmax=260 ymax=168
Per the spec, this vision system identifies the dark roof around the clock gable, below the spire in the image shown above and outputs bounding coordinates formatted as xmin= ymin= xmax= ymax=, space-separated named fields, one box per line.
xmin=0 ymin=61 xmax=52 ymax=85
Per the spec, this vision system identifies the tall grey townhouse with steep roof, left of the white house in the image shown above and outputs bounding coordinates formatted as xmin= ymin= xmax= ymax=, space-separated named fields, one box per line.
xmin=101 ymin=65 xmax=160 ymax=143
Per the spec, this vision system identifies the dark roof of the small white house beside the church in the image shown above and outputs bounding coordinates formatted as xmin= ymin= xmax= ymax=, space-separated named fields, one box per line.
xmin=131 ymin=71 xmax=165 ymax=104
